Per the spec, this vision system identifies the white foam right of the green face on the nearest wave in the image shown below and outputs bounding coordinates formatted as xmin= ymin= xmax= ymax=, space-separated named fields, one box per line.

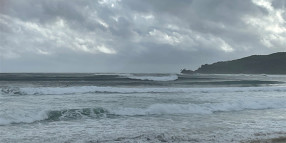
xmin=111 ymin=100 xmax=286 ymax=116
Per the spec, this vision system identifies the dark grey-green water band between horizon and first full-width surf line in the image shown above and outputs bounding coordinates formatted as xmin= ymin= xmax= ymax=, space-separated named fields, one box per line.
xmin=0 ymin=73 xmax=284 ymax=87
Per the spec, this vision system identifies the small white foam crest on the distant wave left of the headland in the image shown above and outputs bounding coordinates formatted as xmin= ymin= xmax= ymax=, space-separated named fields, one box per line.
xmin=124 ymin=74 xmax=178 ymax=81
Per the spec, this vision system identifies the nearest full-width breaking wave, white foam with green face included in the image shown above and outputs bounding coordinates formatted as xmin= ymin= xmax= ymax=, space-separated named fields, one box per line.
xmin=0 ymin=99 xmax=286 ymax=125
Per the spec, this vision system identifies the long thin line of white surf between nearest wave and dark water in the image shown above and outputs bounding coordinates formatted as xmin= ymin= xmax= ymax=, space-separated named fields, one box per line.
xmin=0 ymin=86 xmax=286 ymax=95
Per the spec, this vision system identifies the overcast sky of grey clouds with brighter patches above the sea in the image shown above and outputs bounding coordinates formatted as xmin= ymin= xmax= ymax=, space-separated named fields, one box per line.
xmin=0 ymin=0 xmax=286 ymax=73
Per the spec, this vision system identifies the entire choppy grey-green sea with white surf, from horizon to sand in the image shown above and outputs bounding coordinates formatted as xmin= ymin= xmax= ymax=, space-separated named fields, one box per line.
xmin=0 ymin=73 xmax=286 ymax=143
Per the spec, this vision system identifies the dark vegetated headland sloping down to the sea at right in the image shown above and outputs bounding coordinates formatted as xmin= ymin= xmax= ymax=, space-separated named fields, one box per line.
xmin=181 ymin=52 xmax=286 ymax=74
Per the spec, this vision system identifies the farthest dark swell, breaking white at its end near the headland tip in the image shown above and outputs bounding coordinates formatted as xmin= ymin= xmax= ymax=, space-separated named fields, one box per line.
xmin=0 ymin=73 xmax=178 ymax=81
